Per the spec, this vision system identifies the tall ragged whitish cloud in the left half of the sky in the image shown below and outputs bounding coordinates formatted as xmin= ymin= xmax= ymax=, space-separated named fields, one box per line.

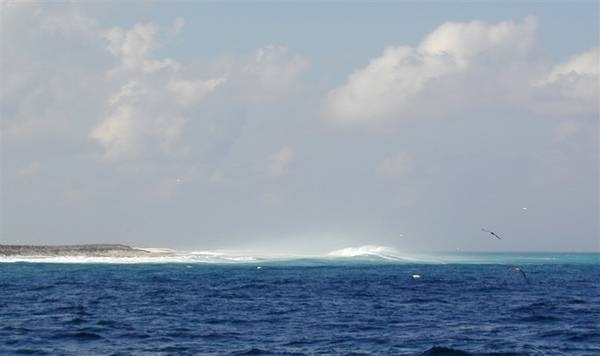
xmin=89 ymin=21 xmax=225 ymax=160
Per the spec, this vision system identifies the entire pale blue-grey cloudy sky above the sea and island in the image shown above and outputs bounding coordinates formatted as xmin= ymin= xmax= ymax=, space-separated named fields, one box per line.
xmin=0 ymin=0 xmax=600 ymax=254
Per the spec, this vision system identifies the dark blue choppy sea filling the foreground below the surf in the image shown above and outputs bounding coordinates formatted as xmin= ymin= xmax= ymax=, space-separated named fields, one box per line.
xmin=0 ymin=263 xmax=600 ymax=355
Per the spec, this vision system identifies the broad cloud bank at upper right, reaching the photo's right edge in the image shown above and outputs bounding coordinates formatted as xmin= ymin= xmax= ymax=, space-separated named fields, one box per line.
xmin=323 ymin=17 xmax=598 ymax=125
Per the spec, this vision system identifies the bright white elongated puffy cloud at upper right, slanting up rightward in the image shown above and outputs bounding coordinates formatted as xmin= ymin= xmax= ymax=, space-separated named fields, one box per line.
xmin=324 ymin=17 xmax=536 ymax=125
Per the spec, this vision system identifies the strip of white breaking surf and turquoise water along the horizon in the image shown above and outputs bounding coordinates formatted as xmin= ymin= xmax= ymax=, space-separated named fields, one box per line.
xmin=0 ymin=245 xmax=600 ymax=265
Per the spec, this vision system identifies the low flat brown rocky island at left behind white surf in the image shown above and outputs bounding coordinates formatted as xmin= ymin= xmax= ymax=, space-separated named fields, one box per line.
xmin=0 ymin=244 xmax=173 ymax=257
